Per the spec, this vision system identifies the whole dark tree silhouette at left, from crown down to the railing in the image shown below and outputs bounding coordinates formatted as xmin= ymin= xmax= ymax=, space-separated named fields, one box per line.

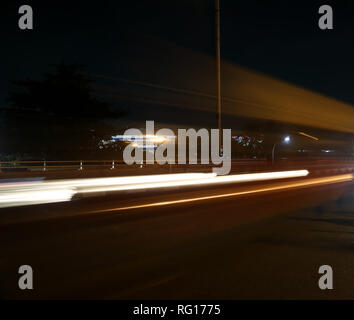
xmin=2 ymin=64 xmax=123 ymax=160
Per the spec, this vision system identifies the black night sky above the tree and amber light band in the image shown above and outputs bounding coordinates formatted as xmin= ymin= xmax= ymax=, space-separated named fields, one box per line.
xmin=0 ymin=0 xmax=354 ymax=129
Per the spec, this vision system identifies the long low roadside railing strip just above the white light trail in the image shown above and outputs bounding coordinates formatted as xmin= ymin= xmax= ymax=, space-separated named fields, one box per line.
xmin=0 ymin=158 xmax=354 ymax=179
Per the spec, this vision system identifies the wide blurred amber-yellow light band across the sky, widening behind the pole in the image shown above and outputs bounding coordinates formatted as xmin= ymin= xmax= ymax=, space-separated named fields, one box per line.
xmin=103 ymin=37 xmax=354 ymax=133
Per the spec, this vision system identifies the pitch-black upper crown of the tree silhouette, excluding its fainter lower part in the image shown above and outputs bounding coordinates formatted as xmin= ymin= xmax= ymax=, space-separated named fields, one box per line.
xmin=10 ymin=64 xmax=113 ymax=120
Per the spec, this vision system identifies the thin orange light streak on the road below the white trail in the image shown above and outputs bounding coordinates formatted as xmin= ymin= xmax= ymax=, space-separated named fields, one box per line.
xmin=92 ymin=174 xmax=353 ymax=213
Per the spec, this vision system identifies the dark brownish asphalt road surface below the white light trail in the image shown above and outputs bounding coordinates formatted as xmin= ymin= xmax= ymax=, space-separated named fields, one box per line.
xmin=0 ymin=171 xmax=354 ymax=299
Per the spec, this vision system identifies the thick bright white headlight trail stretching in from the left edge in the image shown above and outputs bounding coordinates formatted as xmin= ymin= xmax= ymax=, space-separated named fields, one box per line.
xmin=0 ymin=170 xmax=309 ymax=207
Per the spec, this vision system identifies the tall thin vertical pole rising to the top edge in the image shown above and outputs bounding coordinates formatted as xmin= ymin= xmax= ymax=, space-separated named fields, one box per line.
xmin=215 ymin=0 xmax=223 ymax=155
